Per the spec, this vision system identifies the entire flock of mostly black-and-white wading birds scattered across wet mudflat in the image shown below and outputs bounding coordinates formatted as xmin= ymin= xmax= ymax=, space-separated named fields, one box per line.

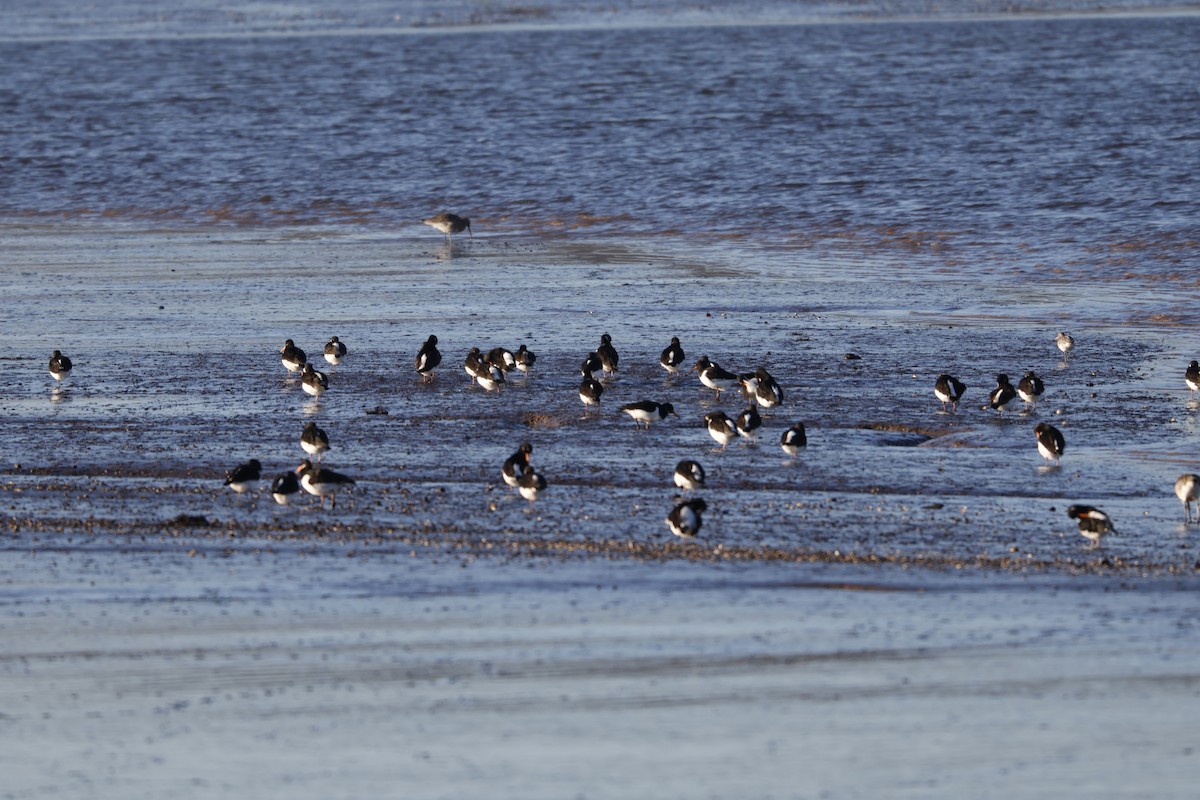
xmin=49 ymin=213 xmax=1200 ymax=543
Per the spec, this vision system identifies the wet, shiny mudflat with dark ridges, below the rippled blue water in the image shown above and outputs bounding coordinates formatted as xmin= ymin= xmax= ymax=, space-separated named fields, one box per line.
xmin=0 ymin=224 xmax=1200 ymax=798
